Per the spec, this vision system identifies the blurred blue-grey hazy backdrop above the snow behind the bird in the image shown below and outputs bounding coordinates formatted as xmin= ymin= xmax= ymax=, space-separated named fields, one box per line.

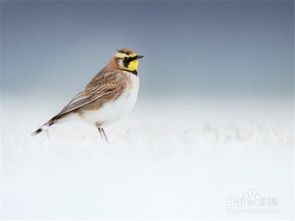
xmin=1 ymin=1 xmax=294 ymax=97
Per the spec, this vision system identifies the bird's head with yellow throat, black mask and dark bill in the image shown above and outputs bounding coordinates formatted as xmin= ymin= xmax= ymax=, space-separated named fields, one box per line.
xmin=113 ymin=48 xmax=143 ymax=72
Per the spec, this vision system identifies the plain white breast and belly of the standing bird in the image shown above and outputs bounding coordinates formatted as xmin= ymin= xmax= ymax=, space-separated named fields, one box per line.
xmin=82 ymin=76 xmax=138 ymax=127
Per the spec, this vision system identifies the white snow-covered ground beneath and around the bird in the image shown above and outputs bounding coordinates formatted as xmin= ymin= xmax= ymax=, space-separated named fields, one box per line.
xmin=1 ymin=97 xmax=294 ymax=219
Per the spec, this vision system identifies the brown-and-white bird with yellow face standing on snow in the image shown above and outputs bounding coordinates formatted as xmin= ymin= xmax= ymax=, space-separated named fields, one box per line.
xmin=32 ymin=48 xmax=143 ymax=142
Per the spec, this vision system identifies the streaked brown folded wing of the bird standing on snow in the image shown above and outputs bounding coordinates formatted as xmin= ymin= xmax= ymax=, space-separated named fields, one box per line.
xmin=54 ymin=71 xmax=126 ymax=119
